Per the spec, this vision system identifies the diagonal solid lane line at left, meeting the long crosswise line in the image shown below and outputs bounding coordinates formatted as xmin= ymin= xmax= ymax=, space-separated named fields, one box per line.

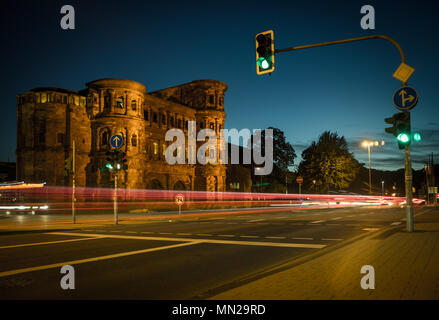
xmin=0 ymin=241 xmax=199 ymax=277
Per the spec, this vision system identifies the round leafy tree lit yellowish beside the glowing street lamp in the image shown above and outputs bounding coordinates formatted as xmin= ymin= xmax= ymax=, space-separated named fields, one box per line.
xmin=298 ymin=131 xmax=360 ymax=192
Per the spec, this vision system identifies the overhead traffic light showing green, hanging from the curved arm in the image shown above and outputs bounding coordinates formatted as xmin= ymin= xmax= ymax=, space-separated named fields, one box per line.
xmin=255 ymin=30 xmax=274 ymax=74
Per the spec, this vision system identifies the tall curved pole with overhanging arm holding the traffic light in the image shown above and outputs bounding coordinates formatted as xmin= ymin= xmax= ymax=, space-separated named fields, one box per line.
xmin=274 ymin=35 xmax=414 ymax=232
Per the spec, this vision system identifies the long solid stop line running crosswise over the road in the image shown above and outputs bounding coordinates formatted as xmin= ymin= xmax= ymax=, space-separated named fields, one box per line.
xmin=46 ymin=232 xmax=327 ymax=249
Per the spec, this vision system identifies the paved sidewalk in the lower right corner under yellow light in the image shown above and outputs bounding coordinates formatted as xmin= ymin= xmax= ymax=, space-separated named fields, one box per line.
xmin=210 ymin=209 xmax=439 ymax=300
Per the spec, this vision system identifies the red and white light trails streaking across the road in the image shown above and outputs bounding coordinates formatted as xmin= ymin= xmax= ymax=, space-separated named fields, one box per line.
xmin=0 ymin=183 xmax=424 ymax=213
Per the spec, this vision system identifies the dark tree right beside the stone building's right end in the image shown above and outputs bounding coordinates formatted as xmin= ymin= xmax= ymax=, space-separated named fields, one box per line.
xmin=249 ymin=127 xmax=296 ymax=193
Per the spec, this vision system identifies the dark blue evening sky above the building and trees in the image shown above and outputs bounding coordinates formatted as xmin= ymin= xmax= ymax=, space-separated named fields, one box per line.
xmin=0 ymin=0 xmax=439 ymax=169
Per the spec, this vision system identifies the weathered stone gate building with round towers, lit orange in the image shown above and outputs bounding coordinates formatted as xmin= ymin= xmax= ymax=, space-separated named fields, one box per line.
xmin=17 ymin=79 xmax=227 ymax=191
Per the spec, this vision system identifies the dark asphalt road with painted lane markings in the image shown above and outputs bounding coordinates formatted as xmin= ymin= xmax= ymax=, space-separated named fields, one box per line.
xmin=0 ymin=207 xmax=423 ymax=299
